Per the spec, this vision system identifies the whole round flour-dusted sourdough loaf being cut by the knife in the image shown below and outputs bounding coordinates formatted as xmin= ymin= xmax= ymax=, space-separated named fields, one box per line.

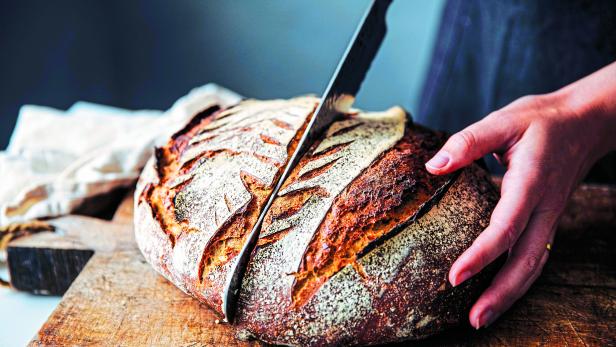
xmin=135 ymin=97 xmax=498 ymax=345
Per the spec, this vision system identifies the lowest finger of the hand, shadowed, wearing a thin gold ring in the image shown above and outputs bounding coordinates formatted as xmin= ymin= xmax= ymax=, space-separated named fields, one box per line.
xmin=469 ymin=210 xmax=559 ymax=329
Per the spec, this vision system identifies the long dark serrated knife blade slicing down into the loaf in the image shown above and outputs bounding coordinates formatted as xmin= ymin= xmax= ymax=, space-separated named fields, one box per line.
xmin=222 ymin=0 xmax=393 ymax=322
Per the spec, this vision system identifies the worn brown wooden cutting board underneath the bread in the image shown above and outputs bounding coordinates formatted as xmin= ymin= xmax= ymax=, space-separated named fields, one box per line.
xmin=9 ymin=181 xmax=616 ymax=346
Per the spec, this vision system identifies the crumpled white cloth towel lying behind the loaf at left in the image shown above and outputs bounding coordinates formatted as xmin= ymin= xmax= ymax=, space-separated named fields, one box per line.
xmin=0 ymin=84 xmax=241 ymax=229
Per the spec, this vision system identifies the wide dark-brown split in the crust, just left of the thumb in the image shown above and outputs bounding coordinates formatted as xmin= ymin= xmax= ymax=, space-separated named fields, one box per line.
xmin=288 ymin=127 xmax=451 ymax=305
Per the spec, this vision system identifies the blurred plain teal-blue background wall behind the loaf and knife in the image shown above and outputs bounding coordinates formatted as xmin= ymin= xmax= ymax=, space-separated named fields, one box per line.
xmin=0 ymin=0 xmax=444 ymax=148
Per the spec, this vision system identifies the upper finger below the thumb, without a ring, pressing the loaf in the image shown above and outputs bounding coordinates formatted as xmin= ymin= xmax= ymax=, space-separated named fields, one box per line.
xmin=449 ymin=167 xmax=543 ymax=286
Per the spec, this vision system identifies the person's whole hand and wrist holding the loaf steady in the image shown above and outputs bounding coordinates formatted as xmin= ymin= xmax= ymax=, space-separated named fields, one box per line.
xmin=426 ymin=63 xmax=616 ymax=329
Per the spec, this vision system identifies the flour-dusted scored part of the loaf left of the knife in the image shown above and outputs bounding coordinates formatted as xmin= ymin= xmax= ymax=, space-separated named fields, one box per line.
xmin=135 ymin=97 xmax=318 ymax=314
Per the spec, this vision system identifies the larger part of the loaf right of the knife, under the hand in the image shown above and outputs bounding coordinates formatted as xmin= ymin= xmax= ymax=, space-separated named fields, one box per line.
xmin=237 ymin=108 xmax=498 ymax=345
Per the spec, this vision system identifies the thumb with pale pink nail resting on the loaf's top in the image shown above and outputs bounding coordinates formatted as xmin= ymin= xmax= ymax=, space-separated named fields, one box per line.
xmin=426 ymin=112 xmax=518 ymax=175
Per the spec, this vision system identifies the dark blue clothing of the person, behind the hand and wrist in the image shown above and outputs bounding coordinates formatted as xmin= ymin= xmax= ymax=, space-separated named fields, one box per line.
xmin=418 ymin=0 xmax=616 ymax=182
